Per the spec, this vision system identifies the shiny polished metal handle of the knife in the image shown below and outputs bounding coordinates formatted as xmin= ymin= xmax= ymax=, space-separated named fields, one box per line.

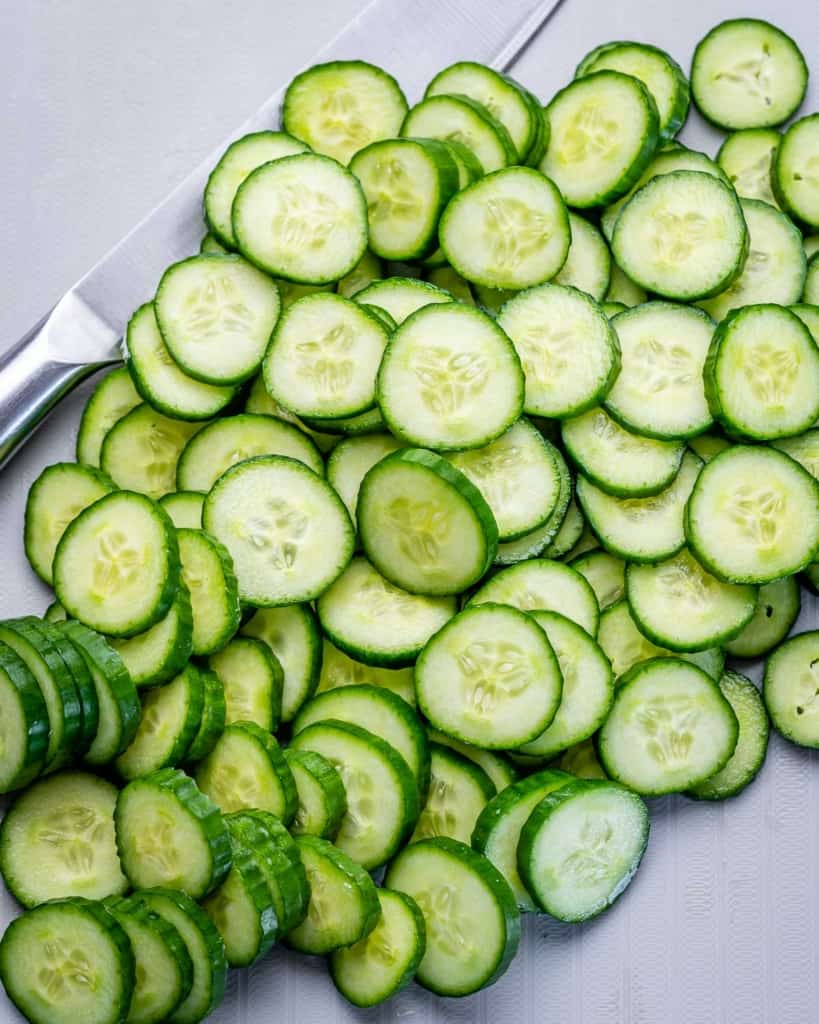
xmin=0 ymin=314 xmax=113 ymax=469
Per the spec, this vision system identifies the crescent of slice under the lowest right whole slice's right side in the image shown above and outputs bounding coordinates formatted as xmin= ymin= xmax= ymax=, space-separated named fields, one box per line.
xmin=687 ymin=672 xmax=770 ymax=800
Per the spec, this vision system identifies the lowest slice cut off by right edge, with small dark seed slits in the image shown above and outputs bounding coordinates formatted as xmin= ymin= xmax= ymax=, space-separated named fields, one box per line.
xmin=763 ymin=630 xmax=819 ymax=748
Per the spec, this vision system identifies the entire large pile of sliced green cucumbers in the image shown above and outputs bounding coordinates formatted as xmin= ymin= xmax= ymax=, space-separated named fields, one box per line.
xmin=0 ymin=19 xmax=819 ymax=1024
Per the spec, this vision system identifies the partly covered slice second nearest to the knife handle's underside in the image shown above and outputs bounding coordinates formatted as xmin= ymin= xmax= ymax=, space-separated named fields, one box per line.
xmin=100 ymin=403 xmax=203 ymax=499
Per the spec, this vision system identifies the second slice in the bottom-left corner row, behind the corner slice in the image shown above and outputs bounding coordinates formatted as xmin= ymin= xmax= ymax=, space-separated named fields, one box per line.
xmin=104 ymin=898 xmax=193 ymax=1024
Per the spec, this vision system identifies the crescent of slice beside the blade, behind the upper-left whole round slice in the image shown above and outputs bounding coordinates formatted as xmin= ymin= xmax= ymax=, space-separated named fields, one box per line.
xmin=204 ymin=131 xmax=308 ymax=249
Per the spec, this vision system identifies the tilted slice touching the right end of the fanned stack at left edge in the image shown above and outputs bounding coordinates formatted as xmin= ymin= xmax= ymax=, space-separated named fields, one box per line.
xmin=116 ymin=665 xmax=205 ymax=779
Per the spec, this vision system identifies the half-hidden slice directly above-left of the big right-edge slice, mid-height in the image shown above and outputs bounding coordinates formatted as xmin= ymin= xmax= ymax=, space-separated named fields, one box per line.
xmin=561 ymin=406 xmax=685 ymax=498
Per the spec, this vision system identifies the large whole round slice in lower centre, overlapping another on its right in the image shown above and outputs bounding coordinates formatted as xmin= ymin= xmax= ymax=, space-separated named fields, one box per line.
xmin=416 ymin=598 xmax=565 ymax=750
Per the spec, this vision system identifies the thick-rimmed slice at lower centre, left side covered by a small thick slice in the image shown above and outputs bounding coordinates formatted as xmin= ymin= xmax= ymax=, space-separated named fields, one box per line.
xmin=291 ymin=719 xmax=419 ymax=870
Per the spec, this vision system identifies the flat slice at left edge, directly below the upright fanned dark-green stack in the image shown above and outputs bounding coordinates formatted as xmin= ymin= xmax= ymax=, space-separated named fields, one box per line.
xmin=0 ymin=771 xmax=128 ymax=907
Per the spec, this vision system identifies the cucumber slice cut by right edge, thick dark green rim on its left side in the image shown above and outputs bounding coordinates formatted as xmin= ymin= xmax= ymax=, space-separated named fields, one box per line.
xmin=703 ymin=304 xmax=819 ymax=440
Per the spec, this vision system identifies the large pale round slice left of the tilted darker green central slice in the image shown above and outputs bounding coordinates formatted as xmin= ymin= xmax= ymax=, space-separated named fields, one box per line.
xmin=202 ymin=456 xmax=355 ymax=606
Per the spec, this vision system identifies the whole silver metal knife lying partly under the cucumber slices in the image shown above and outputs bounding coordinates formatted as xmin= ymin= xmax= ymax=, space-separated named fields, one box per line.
xmin=0 ymin=0 xmax=562 ymax=468
